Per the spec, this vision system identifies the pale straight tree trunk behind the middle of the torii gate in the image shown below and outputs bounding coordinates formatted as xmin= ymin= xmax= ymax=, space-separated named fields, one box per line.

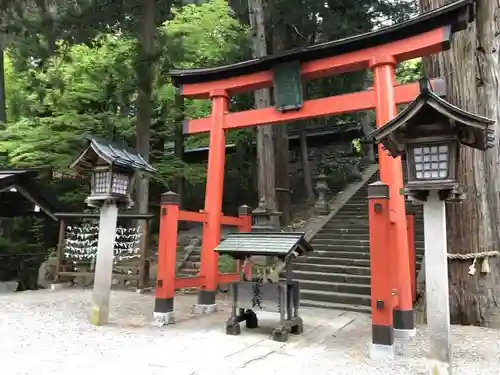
xmin=248 ymin=0 xmax=277 ymax=217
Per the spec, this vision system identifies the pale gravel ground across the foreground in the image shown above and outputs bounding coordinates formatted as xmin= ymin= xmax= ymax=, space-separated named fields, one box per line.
xmin=0 ymin=289 xmax=500 ymax=375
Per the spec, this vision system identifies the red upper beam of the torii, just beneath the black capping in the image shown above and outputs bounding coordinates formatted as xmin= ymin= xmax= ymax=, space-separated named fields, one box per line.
xmin=181 ymin=27 xmax=451 ymax=99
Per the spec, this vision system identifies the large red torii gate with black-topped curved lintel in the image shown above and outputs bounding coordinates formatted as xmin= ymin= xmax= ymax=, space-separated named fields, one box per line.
xmin=159 ymin=0 xmax=474 ymax=352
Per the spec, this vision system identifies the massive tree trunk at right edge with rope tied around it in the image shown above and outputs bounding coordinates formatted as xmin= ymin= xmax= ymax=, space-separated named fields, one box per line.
xmin=420 ymin=0 xmax=500 ymax=326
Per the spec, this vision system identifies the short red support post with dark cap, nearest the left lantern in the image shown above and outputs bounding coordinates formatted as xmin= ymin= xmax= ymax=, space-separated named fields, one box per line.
xmin=154 ymin=191 xmax=180 ymax=326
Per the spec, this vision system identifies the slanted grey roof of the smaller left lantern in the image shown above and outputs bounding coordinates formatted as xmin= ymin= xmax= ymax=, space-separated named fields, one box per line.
xmin=71 ymin=136 xmax=156 ymax=173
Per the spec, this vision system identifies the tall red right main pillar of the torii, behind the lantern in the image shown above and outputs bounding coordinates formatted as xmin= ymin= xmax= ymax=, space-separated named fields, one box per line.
xmin=370 ymin=55 xmax=415 ymax=339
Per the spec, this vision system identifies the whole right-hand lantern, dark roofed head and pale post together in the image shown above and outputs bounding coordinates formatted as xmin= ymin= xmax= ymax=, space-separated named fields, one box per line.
xmin=371 ymin=80 xmax=495 ymax=374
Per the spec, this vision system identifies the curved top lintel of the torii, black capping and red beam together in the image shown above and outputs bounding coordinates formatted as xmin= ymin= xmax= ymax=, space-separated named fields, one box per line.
xmin=170 ymin=0 xmax=474 ymax=98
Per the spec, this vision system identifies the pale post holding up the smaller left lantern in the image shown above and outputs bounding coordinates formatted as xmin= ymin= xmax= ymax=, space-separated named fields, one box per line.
xmin=90 ymin=200 xmax=118 ymax=326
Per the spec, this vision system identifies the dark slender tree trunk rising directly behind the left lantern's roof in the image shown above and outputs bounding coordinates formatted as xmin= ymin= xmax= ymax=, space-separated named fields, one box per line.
xmin=136 ymin=0 xmax=156 ymax=217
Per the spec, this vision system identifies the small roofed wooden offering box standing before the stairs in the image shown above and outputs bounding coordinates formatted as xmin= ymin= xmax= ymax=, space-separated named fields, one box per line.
xmin=215 ymin=232 xmax=312 ymax=341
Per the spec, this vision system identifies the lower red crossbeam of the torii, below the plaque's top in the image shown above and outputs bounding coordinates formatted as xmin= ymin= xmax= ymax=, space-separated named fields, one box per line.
xmin=184 ymin=79 xmax=444 ymax=134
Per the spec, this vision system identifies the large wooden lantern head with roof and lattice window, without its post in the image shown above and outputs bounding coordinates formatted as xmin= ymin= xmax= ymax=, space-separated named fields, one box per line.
xmin=371 ymin=80 xmax=494 ymax=201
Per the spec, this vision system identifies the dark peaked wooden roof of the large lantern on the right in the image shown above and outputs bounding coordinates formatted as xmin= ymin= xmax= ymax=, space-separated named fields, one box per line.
xmin=370 ymin=79 xmax=495 ymax=157
